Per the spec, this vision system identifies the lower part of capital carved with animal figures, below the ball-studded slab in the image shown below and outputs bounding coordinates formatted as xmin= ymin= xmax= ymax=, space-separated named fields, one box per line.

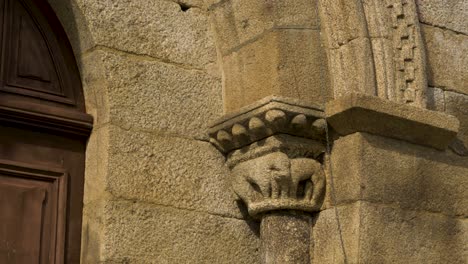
xmin=232 ymin=152 xmax=325 ymax=217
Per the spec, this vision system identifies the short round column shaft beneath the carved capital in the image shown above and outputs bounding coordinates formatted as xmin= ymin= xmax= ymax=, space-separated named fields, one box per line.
xmin=260 ymin=212 xmax=312 ymax=264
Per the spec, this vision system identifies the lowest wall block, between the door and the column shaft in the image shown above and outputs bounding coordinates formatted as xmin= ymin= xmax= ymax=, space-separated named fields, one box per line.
xmin=83 ymin=201 xmax=260 ymax=264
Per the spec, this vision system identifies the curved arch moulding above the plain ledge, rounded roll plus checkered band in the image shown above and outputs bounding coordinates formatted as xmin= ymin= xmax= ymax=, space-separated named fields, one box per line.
xmin=320 ymin=0 xmax=427 ymax=108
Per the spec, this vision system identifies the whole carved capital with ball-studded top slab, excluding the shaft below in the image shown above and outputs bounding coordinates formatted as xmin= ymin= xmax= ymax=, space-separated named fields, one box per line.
xmin=209 ymin=97 xmax=326 ymax=218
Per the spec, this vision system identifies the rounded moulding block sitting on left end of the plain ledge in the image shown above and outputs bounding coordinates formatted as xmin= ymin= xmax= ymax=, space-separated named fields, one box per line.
xmin=328 ymin=38 xmax=377 ymax=98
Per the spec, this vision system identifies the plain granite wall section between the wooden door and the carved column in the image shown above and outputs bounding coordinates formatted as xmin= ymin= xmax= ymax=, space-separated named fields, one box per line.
xmin=49 ymin=0 xmax=258 ymax=263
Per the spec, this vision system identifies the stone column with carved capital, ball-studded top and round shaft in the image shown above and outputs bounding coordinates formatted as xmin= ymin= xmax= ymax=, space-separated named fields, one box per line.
xmin=210 ymin=97 xmax=325 ymax=264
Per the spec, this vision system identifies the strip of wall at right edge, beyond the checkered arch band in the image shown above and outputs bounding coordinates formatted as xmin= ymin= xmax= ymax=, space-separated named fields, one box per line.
xmin=418 ymin=0 xmax=468 ymax=155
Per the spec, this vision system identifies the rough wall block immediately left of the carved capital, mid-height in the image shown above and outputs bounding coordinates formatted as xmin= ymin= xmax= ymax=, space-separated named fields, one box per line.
xmin=105 ymin=126 xmax=242 ymax=218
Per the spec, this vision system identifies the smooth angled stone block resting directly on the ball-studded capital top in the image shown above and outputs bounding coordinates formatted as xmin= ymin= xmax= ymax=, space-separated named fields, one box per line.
xmin=223 ymin=29 xmax=328 ymax=113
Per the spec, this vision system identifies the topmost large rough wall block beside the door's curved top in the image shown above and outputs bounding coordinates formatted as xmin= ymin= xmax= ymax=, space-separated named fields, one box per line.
xmin=71 ymin=0 xmax=216 ymax=68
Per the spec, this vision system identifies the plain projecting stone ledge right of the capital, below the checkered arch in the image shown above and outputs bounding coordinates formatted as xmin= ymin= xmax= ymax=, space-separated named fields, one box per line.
xmin=325 ymin=93 xmax=460 ymax=150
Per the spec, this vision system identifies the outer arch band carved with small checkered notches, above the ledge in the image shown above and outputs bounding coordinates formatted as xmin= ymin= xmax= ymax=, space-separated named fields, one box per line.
xmin=363 ymin=0 xmax=427 ymax=108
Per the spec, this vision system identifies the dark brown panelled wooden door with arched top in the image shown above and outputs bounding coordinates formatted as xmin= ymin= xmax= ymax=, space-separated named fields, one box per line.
xmin=0 ymin=0 xmax=92 ymax=264
